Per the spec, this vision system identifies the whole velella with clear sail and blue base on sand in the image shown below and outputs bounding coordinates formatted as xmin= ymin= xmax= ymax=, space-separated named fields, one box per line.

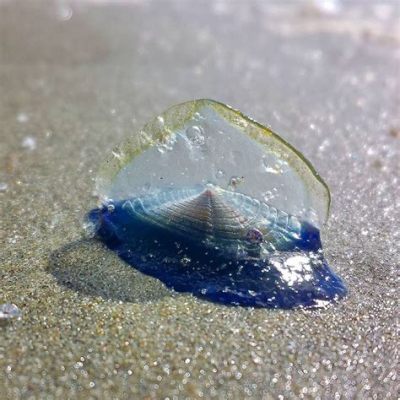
xmin=87 ymin=100 xmax=346 ymax=308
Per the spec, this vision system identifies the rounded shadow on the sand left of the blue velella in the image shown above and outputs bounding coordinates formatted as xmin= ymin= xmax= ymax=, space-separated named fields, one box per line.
xmin=48 ymin=239 xmax=173 ymax=303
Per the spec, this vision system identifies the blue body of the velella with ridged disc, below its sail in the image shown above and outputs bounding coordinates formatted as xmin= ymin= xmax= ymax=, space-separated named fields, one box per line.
xmin=88 ymin=185 xmax=346 ymax=309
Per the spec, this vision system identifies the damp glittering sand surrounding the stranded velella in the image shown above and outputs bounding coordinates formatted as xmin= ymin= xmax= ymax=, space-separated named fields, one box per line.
xmin=0 ymin=0 xmax=400 ymax=400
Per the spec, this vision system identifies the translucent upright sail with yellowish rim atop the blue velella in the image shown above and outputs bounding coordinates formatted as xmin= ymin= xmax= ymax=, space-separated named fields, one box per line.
xmin=96 ymin=100 xmax=330 ymax=227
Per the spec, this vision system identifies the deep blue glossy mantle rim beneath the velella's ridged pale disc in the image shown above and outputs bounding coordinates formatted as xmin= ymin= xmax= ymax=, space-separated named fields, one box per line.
xmin=83 ymin=203 xmax=347 ymax=309
